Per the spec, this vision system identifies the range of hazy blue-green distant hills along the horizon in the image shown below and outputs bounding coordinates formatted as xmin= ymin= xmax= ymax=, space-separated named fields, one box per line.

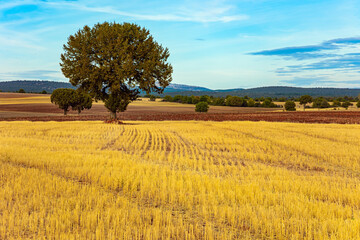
xmin=0 ymin=80 xmax=360 ymax=98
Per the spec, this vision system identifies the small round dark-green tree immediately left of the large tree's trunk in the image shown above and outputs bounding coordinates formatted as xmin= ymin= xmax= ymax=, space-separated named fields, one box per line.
xmin=50 ymin=88 xmax=92 ymax=115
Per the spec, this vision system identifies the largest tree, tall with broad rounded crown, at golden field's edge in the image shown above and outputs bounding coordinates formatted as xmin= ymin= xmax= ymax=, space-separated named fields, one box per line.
xmin=60 ymin=22 xmax=173 ymax=118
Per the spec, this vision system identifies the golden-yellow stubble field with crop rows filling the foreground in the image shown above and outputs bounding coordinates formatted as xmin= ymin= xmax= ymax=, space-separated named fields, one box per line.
xmin=0 ymin=121 xmax=360 ymax=239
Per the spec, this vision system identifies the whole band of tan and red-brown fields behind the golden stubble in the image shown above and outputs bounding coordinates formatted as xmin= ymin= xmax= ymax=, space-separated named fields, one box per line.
xmin=0 ymin=93 xmax=360 ymax=124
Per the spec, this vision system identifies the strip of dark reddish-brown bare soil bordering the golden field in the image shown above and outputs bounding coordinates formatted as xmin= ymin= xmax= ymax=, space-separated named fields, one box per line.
xmin=0 ymin=111 xmax=360 ymax=124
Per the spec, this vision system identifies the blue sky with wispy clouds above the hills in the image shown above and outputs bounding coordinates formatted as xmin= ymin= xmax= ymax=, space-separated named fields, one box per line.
xmin=0 ymin=0 xmax=360 ymax=89
